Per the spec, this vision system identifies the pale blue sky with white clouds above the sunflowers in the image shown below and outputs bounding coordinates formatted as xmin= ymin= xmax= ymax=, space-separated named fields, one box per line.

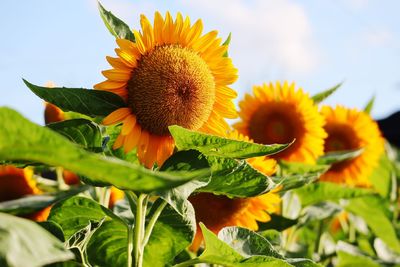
xmin=0 ymin=0 xmax=400 ymax=123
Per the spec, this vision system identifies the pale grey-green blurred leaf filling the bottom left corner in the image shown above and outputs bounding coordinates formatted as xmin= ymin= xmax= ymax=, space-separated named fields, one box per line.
xmin=0 ymin=213 xmax=74 ymax=267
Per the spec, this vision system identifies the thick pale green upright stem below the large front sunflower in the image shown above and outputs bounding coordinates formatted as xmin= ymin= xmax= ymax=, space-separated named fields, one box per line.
xmin=133 ymin=194 xmax=147 ymax=267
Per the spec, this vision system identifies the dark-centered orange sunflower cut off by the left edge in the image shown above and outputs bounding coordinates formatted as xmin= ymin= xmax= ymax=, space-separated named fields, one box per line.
xmin=0 ymin=165 xmax=50 ymax=221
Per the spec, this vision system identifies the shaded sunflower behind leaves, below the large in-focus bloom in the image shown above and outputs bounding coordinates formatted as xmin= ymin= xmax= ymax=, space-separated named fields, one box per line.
xmin=189 ymin=131 xmax=281 ymax=251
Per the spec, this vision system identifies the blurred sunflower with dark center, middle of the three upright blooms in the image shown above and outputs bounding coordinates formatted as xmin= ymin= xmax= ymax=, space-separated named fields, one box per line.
xmin=234 ymin=82 xmax=326 ymax=163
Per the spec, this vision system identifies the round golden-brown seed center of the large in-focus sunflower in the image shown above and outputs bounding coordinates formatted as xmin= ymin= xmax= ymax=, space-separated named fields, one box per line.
xmin=128 ymin=45 xmax=215 ymax=135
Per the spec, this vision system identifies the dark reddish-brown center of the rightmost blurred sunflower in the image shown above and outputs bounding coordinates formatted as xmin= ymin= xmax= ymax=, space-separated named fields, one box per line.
xmin=325 ymin=125 xmax=359 ymax=152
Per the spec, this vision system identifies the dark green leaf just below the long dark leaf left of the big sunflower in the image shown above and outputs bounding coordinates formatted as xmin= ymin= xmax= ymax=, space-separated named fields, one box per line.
xmin=47 ymin=119 xmax=103 ymax=152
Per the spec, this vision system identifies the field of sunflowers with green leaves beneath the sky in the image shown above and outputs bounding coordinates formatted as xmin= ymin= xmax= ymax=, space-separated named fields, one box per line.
xmin=0 ymin=4 xmax=400 ymax=267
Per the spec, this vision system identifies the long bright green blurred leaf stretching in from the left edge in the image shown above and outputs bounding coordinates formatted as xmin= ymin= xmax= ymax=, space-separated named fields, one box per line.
xmin=0 ymin=108 xmax=210 ymax=192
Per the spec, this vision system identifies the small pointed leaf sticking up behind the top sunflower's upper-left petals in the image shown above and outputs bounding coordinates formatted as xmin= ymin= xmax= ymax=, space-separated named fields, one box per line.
xmin=97 ymin=2 xmax=135 ymax=42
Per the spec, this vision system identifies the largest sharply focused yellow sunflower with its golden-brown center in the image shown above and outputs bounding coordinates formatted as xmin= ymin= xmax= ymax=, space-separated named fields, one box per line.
xmin=94 ymin=12 xmax=237 ymax=168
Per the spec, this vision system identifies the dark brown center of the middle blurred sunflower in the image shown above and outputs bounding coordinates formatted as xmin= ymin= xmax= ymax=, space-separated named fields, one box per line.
xmin=249 ymin=103 xmax=298 ymax=147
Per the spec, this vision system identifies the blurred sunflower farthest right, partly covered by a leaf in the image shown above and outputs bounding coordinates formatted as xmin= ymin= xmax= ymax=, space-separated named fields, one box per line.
xmin=320 ymin=106 xmax=384 ymax=187
